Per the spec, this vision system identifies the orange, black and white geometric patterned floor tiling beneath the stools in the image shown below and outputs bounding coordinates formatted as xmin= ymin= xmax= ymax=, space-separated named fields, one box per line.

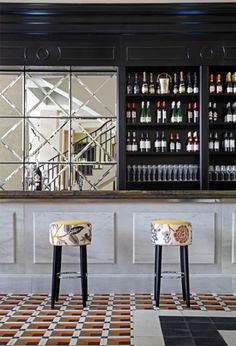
xmin=0 ymin=293 xmax=236 ymax=346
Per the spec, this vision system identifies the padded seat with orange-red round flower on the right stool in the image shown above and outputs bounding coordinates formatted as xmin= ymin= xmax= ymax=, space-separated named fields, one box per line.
xmin=151 ymin=220 xmax=192 ymax=246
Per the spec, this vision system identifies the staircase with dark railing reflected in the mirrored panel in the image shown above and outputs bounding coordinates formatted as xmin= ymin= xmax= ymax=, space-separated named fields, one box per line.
xmin=40 ymin=119 xmax=115 ymax=190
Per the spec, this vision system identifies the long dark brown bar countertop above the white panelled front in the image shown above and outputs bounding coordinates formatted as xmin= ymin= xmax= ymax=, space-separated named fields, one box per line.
xmin=0 ymin=190 xmax=236 ymax=201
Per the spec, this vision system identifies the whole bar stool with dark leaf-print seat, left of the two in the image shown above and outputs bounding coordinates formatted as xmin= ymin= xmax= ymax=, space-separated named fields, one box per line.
xmin=49 ymin=220 xmax=92 ymax=309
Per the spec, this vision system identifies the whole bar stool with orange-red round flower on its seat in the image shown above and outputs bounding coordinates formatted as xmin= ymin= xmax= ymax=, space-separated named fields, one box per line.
xmin=151 ymin=220 xmax=192 ymax=307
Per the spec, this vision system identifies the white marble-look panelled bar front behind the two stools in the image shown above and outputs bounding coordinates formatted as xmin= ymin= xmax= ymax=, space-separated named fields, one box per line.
xmin=0 ymin=199 xmax=236 ymax=293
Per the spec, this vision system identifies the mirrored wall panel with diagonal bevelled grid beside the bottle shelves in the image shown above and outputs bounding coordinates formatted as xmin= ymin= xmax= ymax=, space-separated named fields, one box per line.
xmin=0 ymin=69 xmax=117 ymax=191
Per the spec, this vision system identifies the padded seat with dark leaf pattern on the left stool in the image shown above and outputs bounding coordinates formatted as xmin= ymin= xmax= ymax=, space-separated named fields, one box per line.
xmin=49 ymin=220 xmax=92 ymax=246
